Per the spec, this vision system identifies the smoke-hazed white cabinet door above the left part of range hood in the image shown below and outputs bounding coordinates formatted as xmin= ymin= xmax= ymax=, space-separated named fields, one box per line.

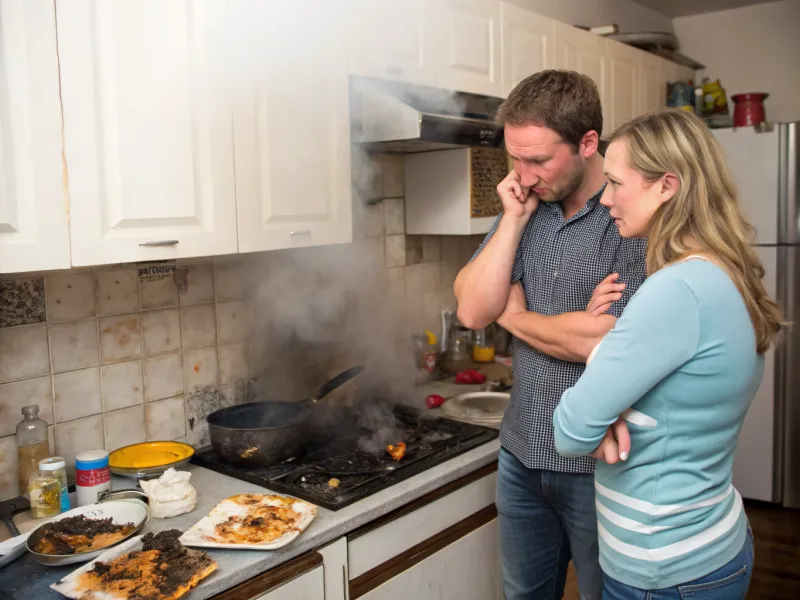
xmin=350 ymin=0 xmax=436 ymax=85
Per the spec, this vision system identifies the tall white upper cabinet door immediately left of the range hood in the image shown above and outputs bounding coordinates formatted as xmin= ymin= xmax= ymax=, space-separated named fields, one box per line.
xmin=231 ymin=0 xmax=353 ymax=252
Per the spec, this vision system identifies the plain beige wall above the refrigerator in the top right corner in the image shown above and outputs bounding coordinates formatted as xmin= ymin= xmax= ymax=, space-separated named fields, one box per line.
xmin=674 ymin=0 xmax=800 ymax=121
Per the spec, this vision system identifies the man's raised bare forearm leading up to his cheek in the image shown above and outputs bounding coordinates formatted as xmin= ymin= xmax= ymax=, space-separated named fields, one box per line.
xmin=453 ymin=215 xmax=528 ymax=329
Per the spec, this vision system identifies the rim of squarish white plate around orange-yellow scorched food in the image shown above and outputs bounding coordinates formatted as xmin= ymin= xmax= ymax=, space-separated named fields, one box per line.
xmin=180 ymin=494 xmax=317 ymax=550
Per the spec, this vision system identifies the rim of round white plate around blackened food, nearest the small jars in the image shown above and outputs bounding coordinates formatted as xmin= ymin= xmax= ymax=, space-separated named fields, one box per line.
xmin=28 ymin=500 xmax=150 ymax=567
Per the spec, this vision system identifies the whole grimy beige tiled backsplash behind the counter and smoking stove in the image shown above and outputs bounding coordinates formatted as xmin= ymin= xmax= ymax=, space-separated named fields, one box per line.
xmin=0 ymin=148 xmax=483 ymax=500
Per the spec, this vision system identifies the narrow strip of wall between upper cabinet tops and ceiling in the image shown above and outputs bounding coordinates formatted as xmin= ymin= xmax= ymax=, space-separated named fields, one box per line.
xmin=510 ymin=0 xmax=672 ymax=33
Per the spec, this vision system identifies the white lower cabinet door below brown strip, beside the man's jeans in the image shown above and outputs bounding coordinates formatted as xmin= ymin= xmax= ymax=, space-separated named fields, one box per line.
xmin=360 ymin=518 xmax=502 ymax=600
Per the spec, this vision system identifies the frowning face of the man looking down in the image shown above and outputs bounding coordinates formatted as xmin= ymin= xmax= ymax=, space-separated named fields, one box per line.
xmin=504 ymin=125 xmax=586 ymax=202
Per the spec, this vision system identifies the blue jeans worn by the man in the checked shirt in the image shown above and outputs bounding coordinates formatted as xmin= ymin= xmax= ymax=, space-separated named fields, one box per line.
xmin=496 ymin=448 xmax=603 ymax=600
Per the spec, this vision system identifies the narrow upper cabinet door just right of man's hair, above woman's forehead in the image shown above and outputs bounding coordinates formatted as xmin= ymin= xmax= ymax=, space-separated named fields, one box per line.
xmin=603 ymin=40 xmax=642 ymax=135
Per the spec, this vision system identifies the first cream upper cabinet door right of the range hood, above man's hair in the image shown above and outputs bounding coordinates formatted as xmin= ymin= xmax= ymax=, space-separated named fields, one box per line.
xmin=500 ymin=2 xmax=555 ymax=98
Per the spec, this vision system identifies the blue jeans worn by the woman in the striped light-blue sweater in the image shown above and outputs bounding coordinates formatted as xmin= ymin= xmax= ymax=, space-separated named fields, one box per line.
xmin=603 ymin=525 xmax=753 ymax=600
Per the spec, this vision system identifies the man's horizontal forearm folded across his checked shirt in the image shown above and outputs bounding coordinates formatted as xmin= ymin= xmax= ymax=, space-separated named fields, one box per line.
xmin=498 ymin=311 xmax=617 ymax=362
